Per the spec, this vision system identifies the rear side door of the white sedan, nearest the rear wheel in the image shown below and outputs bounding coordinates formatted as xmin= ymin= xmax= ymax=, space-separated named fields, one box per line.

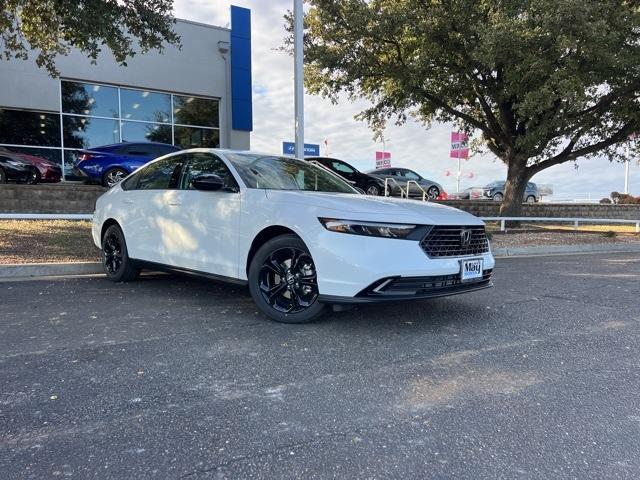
xmin=119 ymin=155 xmax=186 ymax=265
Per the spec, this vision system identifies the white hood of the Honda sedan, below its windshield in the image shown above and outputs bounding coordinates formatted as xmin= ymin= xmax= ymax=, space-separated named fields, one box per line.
xmin=265 ymin=190 xmax=483 ymax=225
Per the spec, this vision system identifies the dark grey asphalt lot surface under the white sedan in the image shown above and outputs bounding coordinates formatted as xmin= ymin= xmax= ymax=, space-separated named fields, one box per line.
xmin=0 ymin=254 xmax=640 ymax=479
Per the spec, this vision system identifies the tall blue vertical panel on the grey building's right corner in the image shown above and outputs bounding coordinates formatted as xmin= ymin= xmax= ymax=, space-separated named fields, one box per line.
xmin=231 ymin=5 xmax=253 ymax=132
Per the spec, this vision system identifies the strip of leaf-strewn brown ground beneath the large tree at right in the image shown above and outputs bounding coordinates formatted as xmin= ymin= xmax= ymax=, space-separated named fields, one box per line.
xmin=491 ymin=231 xmax=640 ymax=248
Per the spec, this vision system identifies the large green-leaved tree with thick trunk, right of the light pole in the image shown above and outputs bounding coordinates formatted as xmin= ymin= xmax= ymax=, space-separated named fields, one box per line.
xmin=292 ymin=0 xmax=640 ymax=216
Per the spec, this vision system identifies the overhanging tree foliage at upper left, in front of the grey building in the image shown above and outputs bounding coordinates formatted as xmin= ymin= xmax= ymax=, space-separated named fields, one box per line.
xmin=0 ymin=0 xmax=180 ymax=76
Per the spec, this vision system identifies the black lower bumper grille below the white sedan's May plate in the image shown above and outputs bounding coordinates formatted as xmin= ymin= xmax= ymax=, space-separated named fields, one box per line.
xmin=358 ymin=269 xmax=493 ymax=297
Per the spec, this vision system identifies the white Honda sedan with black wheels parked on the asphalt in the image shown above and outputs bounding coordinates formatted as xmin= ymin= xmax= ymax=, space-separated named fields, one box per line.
xmin=93 ymin=149 xmax=494 ymax=323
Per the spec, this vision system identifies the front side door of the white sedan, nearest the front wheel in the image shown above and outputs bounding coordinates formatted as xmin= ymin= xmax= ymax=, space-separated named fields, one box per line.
xmin=164 ymin=152 xmax=241 ymax=278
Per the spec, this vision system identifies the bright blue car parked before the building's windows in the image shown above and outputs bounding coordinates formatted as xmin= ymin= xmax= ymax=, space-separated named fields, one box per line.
xmin=73 ymin=142 xmax=181 ymax=188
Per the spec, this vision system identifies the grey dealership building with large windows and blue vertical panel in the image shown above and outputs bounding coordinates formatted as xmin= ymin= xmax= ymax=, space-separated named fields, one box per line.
xmin=0 ymin=6 xmax=253 ymax=180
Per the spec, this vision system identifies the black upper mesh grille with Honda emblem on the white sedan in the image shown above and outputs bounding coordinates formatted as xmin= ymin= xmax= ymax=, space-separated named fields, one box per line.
xmin=420 ymin=225 xmax=489 ymax=258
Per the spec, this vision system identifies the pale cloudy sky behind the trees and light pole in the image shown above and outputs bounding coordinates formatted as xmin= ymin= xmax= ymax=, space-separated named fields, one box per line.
xmin=174 ymin=0 xmax=640 ymax=200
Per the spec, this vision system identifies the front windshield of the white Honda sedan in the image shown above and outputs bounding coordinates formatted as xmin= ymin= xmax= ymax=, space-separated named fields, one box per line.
xmin=225 ymin=153 xmax=358 ymax=193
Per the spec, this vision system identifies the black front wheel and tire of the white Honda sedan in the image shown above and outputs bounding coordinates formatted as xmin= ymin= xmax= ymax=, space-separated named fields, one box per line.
xmin=249 ymin=234 xmax=326 ymax=323
